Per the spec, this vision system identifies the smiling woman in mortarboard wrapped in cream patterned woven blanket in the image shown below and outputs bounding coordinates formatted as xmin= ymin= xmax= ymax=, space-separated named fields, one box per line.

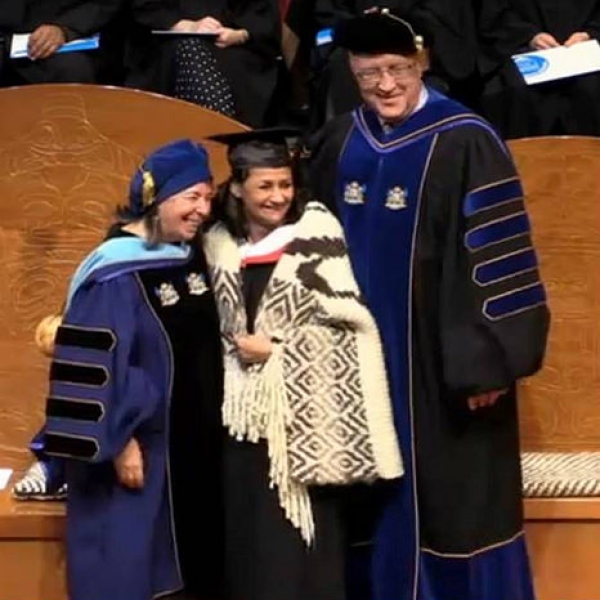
xmin=205 ymin=129 xmax=402 ymax=600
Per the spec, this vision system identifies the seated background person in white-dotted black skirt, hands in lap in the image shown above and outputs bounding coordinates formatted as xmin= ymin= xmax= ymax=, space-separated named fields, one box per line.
xmin=126 ymin=0 xmax=281 ymax=127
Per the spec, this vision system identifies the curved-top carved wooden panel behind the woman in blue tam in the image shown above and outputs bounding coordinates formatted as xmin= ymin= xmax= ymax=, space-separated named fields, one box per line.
xmin=0 ymin=85 xmax=244 ymax=468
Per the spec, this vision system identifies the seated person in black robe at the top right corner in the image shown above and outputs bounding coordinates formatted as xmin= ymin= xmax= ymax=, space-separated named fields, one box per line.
xmin=479 ymin=0 xmax=600 ymax=138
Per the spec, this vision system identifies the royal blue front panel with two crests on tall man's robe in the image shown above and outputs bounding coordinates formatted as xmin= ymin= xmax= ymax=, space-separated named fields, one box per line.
xmin=337 ymin=113 xmax=433 ymax=600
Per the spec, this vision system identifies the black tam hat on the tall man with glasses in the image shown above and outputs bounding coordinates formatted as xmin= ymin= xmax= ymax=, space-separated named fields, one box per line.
xmin=333 ymin=8 xmax=425 ymax=56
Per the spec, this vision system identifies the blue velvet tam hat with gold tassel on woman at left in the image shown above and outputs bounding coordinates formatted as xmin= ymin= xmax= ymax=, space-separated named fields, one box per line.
xmin=129 ymin=140 xmax=212 ymax=217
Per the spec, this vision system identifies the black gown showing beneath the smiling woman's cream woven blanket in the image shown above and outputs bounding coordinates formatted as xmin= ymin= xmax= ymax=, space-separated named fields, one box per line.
xmin=224 ymin=264 xmax=345 ymax=600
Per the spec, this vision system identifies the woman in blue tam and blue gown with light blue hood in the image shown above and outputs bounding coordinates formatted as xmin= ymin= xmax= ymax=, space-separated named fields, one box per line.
xmin=45 ymin=140 xmax=222 ymax=600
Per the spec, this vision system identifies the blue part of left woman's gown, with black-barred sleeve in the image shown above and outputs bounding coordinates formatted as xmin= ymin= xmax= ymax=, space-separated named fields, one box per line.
xmin=45 ymin=264 xmax=182 ymax=600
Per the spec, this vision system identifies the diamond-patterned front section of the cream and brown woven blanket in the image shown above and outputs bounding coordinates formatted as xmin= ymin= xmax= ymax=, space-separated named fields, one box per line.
xmin=284 ymin=326 xmax=376 ymax=485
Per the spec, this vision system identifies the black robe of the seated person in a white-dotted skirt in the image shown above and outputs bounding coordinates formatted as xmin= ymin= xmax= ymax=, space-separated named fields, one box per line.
xmin=127 ymin=0 xmax=281 ymax=127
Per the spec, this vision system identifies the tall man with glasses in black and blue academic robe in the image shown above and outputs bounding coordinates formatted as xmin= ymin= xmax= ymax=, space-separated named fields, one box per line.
xmin=310 ymin=13 xmax=549 ymax=600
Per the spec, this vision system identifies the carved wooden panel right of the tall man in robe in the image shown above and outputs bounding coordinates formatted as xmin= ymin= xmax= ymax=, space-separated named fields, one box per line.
xmin=510 ymin=137 xmax=600 ymax=451
